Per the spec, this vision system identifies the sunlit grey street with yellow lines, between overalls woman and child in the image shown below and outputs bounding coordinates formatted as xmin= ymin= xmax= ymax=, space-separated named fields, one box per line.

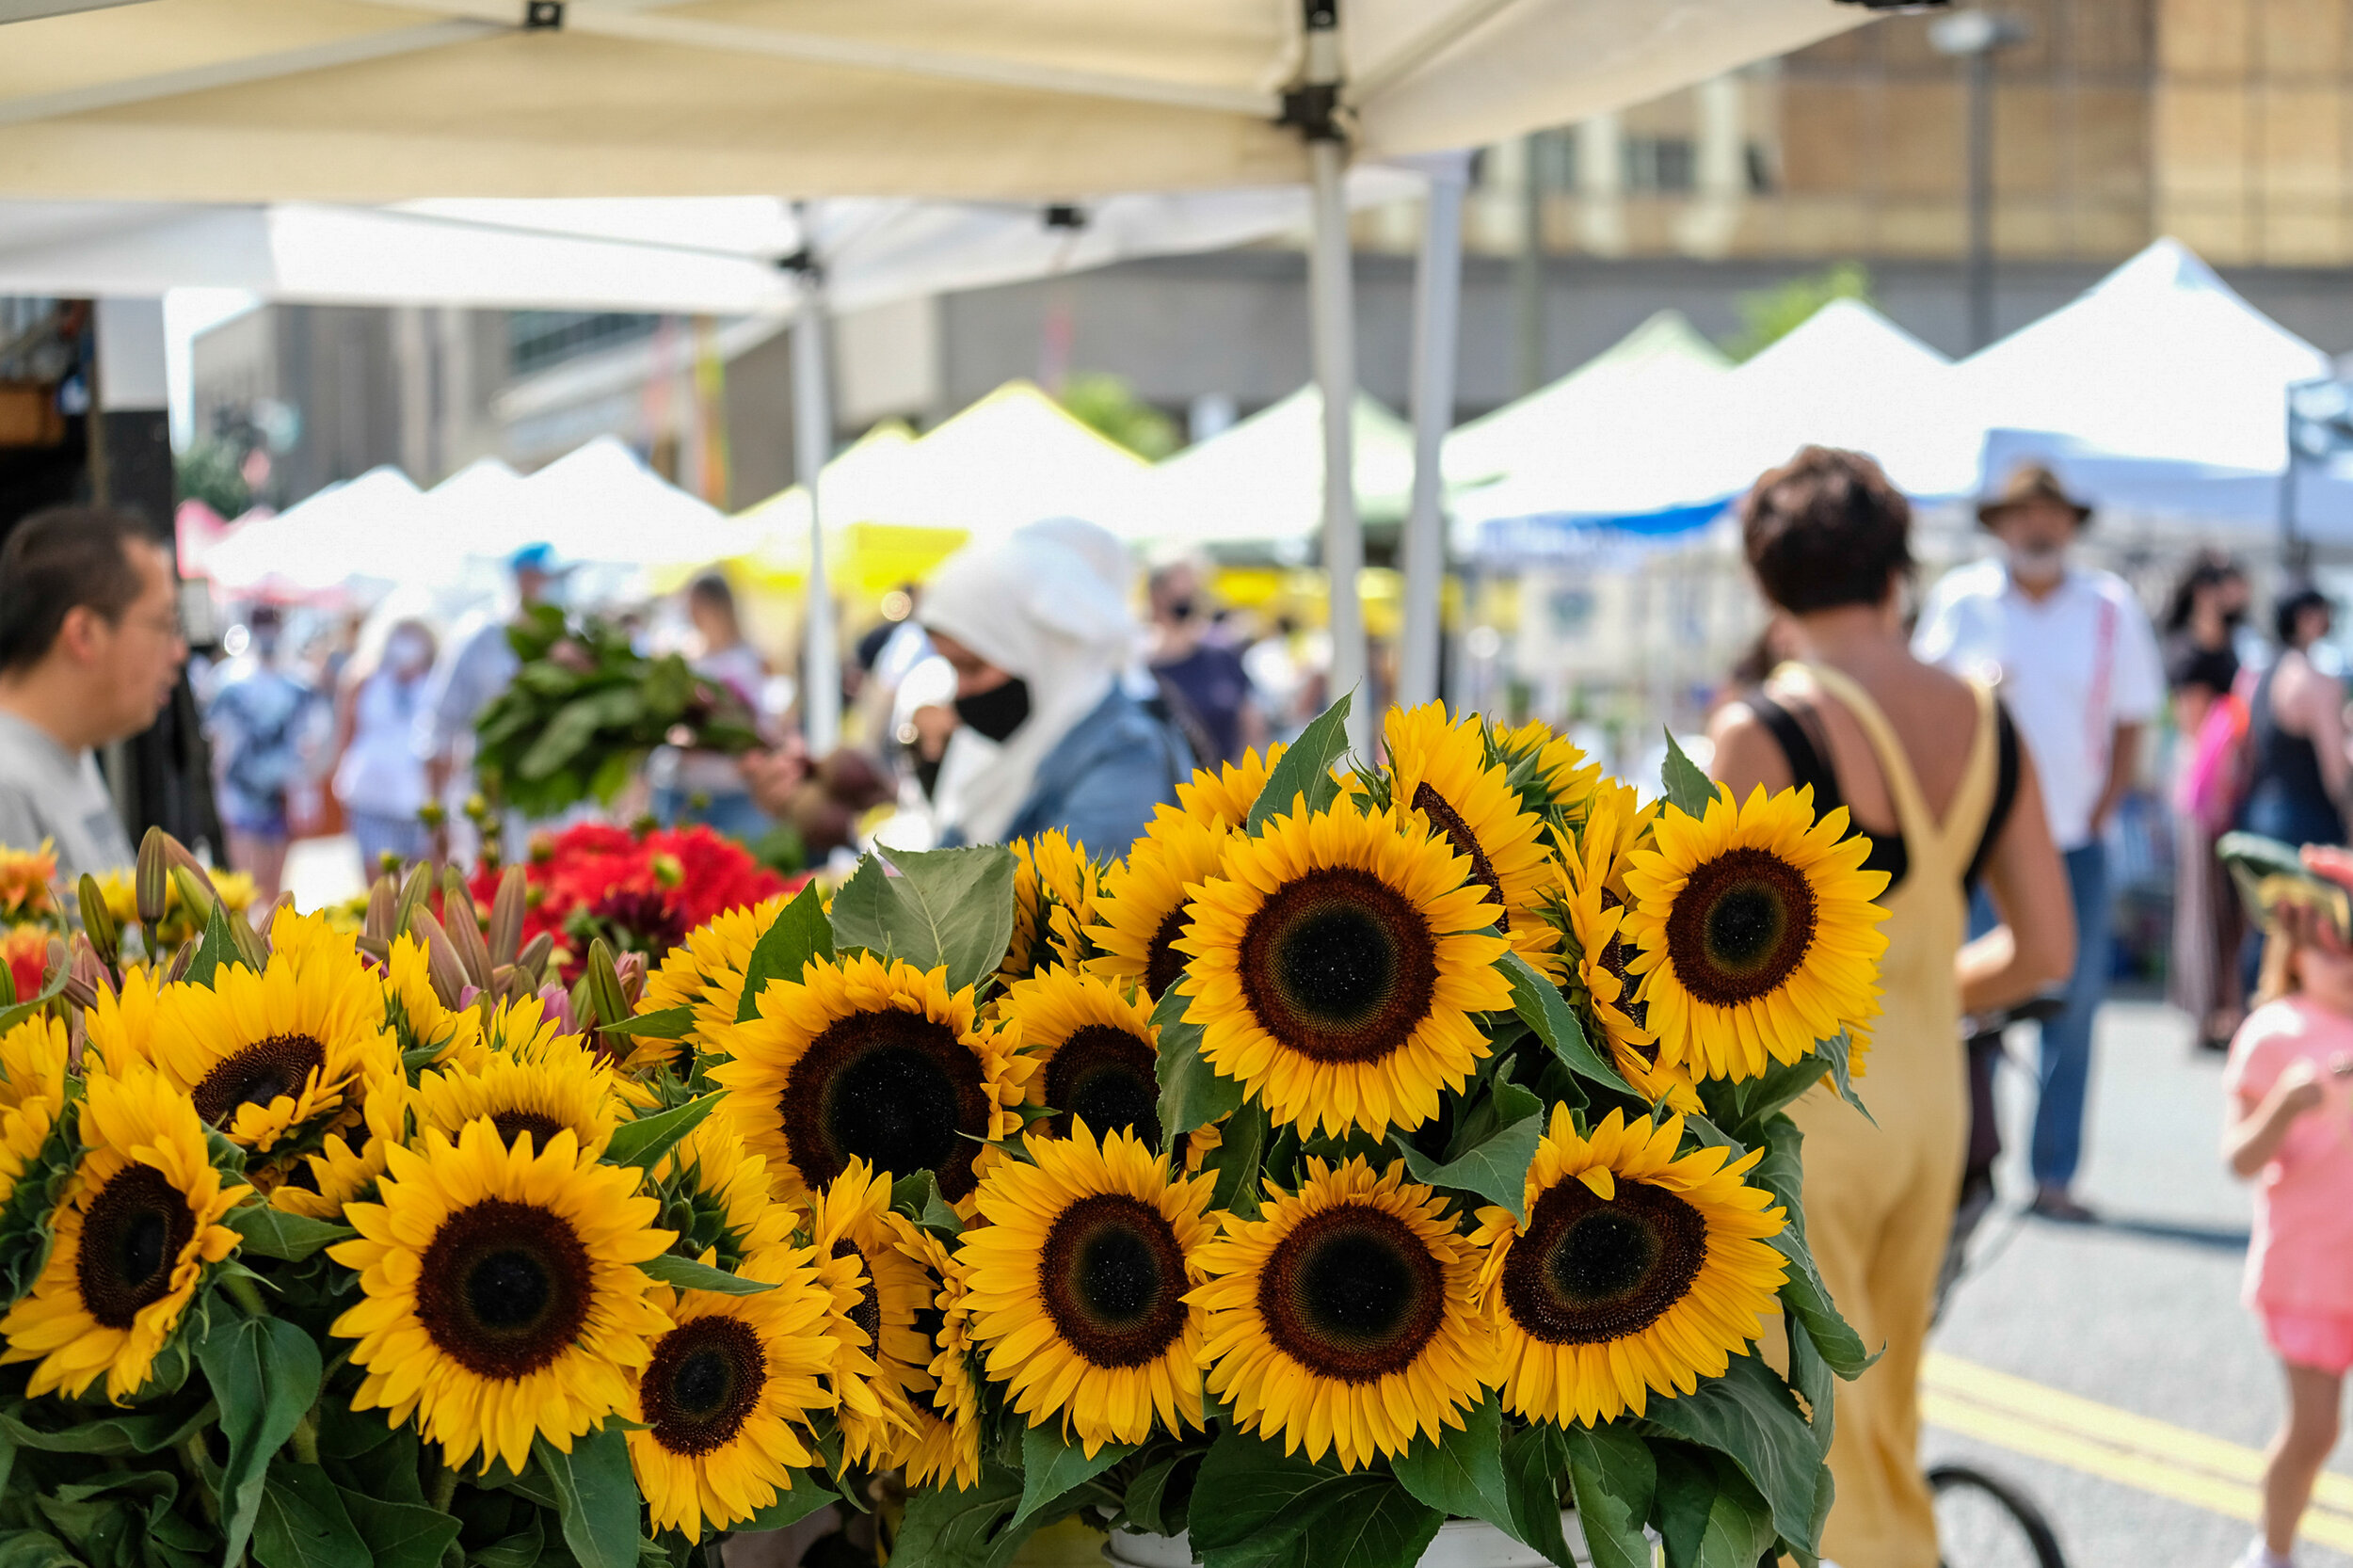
xmin=1929 ymin=1000 xmax=2353 ymax=1568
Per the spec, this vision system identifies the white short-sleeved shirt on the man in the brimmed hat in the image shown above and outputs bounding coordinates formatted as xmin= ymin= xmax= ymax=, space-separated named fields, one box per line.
xmin=1913 ymin=560 xmax=2165 ymax=850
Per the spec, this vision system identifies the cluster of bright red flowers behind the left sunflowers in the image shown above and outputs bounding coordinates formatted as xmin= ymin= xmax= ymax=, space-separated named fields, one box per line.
xmin=473 ymin=822 xmax=786 ymax=980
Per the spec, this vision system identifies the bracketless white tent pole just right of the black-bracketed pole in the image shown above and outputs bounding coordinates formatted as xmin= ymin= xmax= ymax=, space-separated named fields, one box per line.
xmin=1398 ymin=153 xmax=1471 ymax=709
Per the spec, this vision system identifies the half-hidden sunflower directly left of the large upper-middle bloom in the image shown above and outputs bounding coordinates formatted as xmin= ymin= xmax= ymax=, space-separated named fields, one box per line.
xmin=998 ymin=968 xmax=1160 ymax=1149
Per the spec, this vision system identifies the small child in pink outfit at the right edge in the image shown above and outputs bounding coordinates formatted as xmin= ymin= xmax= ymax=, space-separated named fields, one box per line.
xmin=2224 ymin=850 xmax=2353 ymax=1568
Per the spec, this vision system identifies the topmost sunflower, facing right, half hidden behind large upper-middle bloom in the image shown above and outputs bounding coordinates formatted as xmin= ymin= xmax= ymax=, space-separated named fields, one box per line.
xmin=1382 ymin=701 xmax=1553 ymax=952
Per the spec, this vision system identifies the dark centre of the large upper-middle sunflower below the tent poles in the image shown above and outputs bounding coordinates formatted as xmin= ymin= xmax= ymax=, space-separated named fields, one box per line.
xmin=1238 ymin=867 xmax=1438 ymax=1062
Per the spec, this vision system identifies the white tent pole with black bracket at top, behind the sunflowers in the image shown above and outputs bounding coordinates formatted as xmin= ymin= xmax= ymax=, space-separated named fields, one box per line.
xmin=1289 ymin=0 xmax=1374 ymax=760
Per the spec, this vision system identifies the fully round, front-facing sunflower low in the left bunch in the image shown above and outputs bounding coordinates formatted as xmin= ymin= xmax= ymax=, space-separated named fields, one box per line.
xmin=328 ymin=1121 xmax=673 ymax=1474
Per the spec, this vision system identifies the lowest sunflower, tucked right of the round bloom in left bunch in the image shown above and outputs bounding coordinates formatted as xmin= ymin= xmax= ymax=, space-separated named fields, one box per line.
xmin=624 ymin=1248 xmax=833 ymax=1542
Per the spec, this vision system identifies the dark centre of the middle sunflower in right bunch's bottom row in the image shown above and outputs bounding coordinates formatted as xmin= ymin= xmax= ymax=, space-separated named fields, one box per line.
xmin=1259 ymin=1203 xmax=1448 ymax=1382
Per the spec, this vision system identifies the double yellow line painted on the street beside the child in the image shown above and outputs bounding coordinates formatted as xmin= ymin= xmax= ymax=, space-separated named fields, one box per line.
xmin=1920 ymin=1356 xmax=2353 ymax=1551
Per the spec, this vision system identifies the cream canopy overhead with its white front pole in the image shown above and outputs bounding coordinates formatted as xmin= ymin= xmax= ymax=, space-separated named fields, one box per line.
xmin=0 ymin=0 xmax=1868 ymax=746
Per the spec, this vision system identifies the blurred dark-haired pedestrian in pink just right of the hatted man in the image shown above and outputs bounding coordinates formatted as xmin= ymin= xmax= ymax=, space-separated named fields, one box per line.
xmin=2165 ymin=551 xmax=2248 ymax=1050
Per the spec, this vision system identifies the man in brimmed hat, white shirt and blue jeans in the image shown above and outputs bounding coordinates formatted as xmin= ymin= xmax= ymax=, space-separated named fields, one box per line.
xmin=1913 ymin=464 xmax=2165 ymax=1222
